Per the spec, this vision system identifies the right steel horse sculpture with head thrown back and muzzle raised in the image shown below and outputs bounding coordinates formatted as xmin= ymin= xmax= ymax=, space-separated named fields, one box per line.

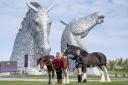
xmin=61 ymin=12 xmax=104 ymax=52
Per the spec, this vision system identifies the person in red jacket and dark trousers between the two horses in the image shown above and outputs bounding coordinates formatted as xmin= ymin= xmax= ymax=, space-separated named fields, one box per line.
xmin=53 ymin=52 xmax=64 ymax=84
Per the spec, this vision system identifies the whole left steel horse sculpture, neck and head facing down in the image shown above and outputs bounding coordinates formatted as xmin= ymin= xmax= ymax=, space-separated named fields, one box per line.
xmin=10 ymin=2 xmax=53 ymax=73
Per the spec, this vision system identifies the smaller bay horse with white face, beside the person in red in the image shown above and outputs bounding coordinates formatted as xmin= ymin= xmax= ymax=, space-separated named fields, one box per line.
xmin=37 ymin=55 xmax=69 ymax=84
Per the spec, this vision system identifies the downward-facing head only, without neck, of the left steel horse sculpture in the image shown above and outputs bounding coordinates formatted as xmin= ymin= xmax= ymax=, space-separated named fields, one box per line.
xmin=27 ymin=2 xmax=51 ymax=57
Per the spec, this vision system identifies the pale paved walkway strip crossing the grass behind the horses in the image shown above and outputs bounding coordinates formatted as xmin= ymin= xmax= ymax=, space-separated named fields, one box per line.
xmin=0 ymin=78 xmax=128 ymax=81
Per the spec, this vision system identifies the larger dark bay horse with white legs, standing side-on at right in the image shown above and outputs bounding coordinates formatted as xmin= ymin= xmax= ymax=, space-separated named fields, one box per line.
xmin=63 ymin=44 xmax=111 ymax=82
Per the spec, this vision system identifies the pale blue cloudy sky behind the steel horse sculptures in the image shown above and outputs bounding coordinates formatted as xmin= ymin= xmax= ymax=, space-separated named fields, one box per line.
xmin=0 ymin=0 xmax=128 ymax=61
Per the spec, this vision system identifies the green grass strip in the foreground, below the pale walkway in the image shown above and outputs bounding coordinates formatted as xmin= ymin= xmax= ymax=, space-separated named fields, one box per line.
xmin=0 ymin=81 xmax=128 ymax=85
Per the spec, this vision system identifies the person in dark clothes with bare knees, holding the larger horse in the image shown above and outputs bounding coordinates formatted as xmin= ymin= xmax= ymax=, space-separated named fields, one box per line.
xmin=69 ymin=50 xmax=85 ymax=83
